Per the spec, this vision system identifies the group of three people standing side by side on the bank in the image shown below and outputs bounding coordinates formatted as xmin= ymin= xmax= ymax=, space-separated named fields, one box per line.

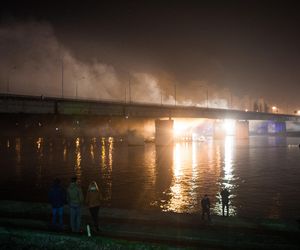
xmin=49 ymin=177 xmax=101 ymax=232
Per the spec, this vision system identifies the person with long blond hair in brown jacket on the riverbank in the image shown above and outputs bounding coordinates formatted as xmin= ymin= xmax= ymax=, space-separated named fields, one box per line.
xmin=86 ymin=181 xmax=101 ymax=231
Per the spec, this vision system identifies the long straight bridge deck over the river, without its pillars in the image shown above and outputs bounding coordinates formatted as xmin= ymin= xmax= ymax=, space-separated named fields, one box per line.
xmin=0 ymin=94 xmax=300 ymax=121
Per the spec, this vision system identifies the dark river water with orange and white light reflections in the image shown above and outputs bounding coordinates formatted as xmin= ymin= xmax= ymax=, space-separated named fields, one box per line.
xmin=0 ymin=136 xmax=300 ymax=218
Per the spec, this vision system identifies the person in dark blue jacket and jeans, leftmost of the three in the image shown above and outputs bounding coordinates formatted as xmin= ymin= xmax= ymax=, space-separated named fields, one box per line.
xmin=48 ymin=178 xmax=66 ymax=229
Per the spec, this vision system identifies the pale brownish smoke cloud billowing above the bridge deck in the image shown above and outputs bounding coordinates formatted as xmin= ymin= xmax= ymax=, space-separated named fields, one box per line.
xmin=0 ymin=21 xmax=251 ymax=109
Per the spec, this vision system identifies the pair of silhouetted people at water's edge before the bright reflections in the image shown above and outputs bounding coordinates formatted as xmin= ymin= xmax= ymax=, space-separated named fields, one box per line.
xmin=201 ymin=188 xmax=230 ymax=221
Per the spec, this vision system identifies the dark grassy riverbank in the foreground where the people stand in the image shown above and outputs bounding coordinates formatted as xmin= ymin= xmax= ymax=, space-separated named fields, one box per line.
xmin=0 ymin=201 xmax=300 ymax=249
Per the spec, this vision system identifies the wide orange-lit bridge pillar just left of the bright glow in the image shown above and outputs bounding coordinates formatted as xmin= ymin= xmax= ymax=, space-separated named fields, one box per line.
xmin=155 ymin=120 xmax=174 ymax=146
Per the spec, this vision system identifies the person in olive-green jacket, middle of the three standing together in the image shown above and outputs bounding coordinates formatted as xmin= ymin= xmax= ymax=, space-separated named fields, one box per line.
xmin=67 ymin=177 xmax=83 ymax=233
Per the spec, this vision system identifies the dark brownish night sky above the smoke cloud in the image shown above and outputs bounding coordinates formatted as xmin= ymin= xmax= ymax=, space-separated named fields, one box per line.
xmin=1 ymin=0 xmax=300 ymax=107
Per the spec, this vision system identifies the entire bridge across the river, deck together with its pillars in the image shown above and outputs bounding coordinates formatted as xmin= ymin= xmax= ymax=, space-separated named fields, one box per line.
xmin=0 ymin=94 xmax=300 ymax=144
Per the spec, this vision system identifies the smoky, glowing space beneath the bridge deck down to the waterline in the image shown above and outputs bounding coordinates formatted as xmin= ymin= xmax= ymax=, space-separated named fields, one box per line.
xmin=0 ymin=114 xmax=300 ymax=145
